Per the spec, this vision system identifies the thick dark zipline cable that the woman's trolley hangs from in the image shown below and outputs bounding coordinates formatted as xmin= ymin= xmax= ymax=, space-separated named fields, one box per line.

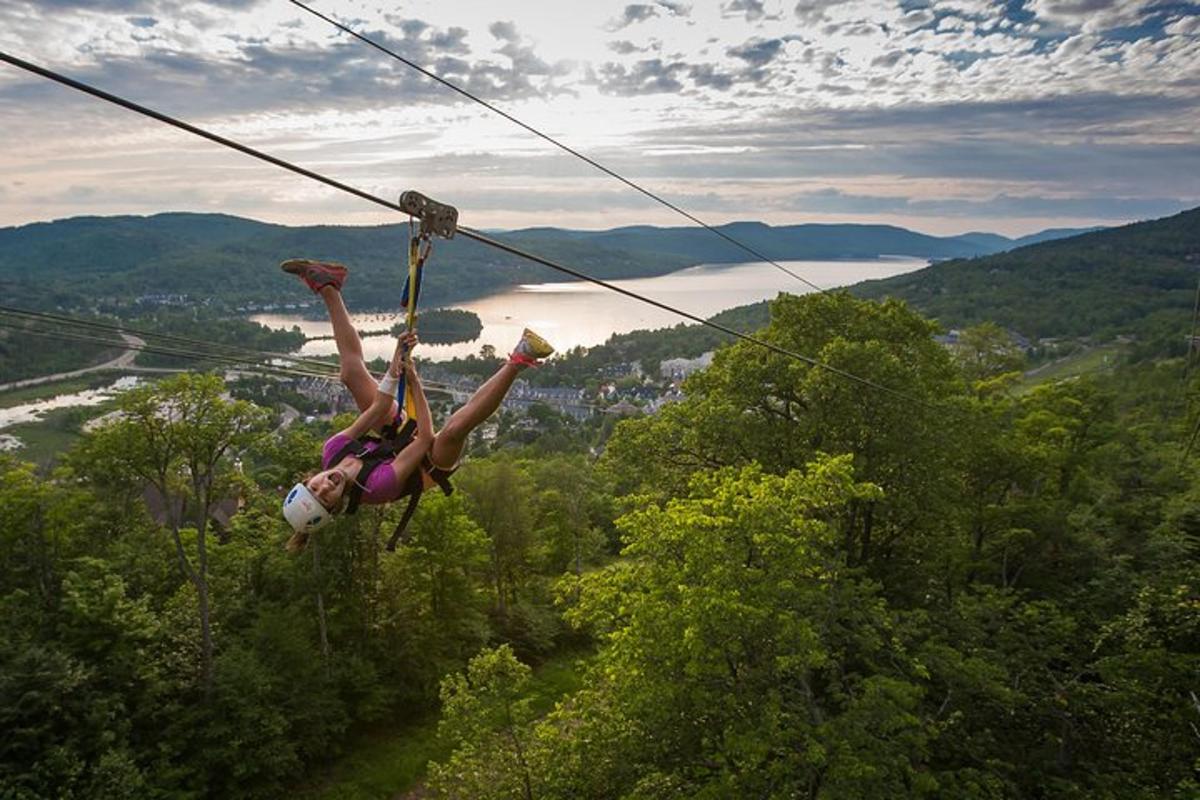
xmin=0 ymin=52 xmax=932 ymax=408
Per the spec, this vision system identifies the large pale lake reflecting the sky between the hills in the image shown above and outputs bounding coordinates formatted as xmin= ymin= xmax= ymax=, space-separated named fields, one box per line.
xmin=251 ymin=257 xmax=928 ymax=361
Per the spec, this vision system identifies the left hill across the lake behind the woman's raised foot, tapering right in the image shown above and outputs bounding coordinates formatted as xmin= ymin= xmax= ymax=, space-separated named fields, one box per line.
xmin=0 ymin=213 xmax=686 ymax=312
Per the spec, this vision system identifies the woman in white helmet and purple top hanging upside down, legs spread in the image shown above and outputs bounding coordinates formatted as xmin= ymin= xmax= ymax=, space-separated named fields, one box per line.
xmin=280 ymin=259 xmax=554 ymax=551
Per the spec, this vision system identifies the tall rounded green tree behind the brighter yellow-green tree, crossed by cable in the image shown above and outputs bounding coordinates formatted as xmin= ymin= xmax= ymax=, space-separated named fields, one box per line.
xmin=604 ymin=293 xmax=968 ymax=593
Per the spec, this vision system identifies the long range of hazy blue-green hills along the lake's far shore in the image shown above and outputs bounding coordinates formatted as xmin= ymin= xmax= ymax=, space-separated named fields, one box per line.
xmin=0 ymin=213 xmax=1089 ymax=311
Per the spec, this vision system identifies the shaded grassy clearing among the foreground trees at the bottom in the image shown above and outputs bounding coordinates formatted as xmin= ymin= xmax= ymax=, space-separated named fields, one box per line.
xmin=302 ymin=649 xmax=592 ymax=800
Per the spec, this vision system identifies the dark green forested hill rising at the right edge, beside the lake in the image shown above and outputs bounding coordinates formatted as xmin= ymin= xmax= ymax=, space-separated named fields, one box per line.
xmin=852 ymin=209 xmax=1200 ymax=337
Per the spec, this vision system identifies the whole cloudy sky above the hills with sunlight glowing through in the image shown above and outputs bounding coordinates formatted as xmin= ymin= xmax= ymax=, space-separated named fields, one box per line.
xmin=0 ymin=0 xmax=1200 ymax=235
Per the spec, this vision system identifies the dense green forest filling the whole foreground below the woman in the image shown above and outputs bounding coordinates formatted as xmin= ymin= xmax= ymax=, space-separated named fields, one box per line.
xmin=0 ymin=284 xmax=1200 ymax=800
